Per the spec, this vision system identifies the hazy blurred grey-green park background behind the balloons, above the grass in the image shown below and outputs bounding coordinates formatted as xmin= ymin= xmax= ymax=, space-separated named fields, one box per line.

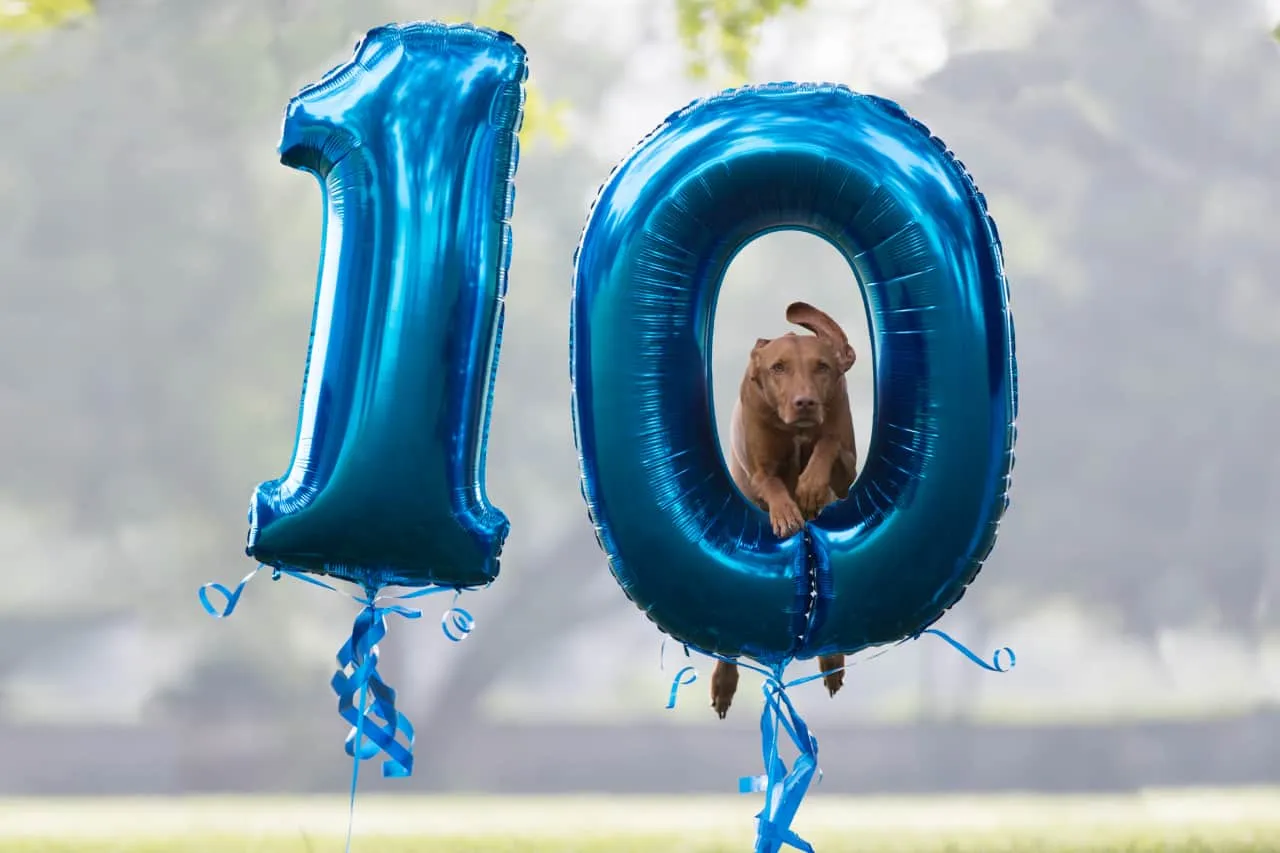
xmin=0 ymin=0 xmax=1280 ymax=794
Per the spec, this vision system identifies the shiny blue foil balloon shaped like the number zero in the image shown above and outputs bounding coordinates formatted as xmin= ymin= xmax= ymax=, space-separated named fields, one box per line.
xmin=570 ymin=83 xmax=1016 ymax=665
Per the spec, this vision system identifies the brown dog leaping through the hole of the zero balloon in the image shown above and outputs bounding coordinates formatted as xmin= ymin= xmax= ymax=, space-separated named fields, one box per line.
xmin=712 ymin=302 xmax=858 ymax=720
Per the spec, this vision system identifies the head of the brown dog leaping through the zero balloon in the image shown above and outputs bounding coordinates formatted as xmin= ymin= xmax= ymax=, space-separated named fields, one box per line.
xmin=749 ymin=302 xmax=856 ymax=429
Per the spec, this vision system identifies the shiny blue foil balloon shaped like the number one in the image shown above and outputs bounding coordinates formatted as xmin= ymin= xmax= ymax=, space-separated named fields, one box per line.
xmin=247 ymin=23 xmax=526 ymax=589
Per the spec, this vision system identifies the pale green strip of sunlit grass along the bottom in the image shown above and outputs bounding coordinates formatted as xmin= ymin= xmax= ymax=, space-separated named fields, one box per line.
xmin=0 ymin=789 xmax=1280 ymax=853
